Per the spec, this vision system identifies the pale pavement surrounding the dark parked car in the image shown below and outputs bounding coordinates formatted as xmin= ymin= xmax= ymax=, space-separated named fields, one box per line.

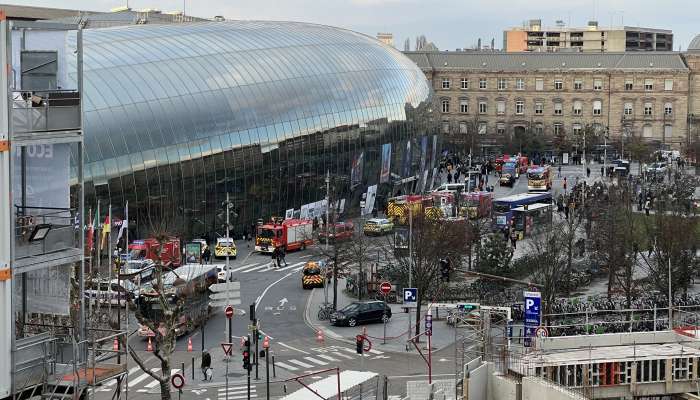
xmin=304 ymin=279 xmax=454 ymax=352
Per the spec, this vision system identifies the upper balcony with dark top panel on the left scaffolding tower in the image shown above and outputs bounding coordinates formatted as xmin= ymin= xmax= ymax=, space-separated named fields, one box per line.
xmin=11 ymin=90 xmax=80 ymax=133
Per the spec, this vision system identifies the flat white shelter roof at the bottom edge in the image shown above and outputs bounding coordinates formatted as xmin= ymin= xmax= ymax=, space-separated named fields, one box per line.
xmin=282 ymin=371 xmax=379 ymax=400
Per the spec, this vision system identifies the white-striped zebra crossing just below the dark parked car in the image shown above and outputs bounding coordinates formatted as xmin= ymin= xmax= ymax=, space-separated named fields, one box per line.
xmin=275 ymin=343 xmax=389 ymax=372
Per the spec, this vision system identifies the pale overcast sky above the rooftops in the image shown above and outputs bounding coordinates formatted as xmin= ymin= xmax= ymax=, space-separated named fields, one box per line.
xmin=15 ymin=0 xmax=700 ymax=50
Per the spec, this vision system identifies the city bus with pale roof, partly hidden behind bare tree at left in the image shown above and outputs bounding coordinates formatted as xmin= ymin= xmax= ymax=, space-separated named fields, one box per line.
xmin=136 ymin=264 xmax=218 ymax=337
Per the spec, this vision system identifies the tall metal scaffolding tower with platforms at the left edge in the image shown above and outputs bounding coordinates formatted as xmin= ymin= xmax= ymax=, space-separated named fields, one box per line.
xmin=0 ymin=17 xmax=128 ymax=399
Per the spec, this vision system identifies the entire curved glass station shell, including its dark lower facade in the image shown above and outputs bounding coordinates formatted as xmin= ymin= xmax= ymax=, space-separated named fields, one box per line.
xmin=72 ymin=21 xmax=437 ymax=237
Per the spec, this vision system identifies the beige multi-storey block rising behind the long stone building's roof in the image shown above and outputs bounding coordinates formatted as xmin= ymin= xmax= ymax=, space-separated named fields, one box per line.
xmin=503 ymin=19 xmax=673 ymax=53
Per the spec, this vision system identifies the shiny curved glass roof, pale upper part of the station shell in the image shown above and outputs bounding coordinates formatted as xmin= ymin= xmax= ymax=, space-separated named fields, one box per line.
xmin=71 ymin=21 xmax=430 ymax=181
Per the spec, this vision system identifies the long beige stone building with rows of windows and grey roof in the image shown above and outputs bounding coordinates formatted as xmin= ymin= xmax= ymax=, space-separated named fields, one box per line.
xmin=406 ymin=51 xmax=688 ymax=156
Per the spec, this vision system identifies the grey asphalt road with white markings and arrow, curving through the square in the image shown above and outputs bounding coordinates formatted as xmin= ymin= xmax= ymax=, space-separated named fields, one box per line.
xmin=95 ymin=164 xmax=599 ymax=400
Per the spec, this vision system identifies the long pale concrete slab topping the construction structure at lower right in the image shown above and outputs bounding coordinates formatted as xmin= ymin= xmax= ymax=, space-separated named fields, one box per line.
xmin=536 ymin=331 xmax=700 ymax=350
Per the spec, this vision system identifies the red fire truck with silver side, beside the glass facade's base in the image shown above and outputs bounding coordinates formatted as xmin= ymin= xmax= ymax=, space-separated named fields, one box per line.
xmin=255 ymin=218 xmax=314 ymax=253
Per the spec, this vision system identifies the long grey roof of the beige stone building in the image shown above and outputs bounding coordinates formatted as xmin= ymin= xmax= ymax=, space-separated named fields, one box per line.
xmin=404 ymin=50 xmax=688 ymax=72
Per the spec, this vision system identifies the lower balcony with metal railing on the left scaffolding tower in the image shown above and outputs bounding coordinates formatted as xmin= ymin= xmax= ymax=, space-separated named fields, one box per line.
xmin=15 ymin=205 xmax=80 ymax=259
